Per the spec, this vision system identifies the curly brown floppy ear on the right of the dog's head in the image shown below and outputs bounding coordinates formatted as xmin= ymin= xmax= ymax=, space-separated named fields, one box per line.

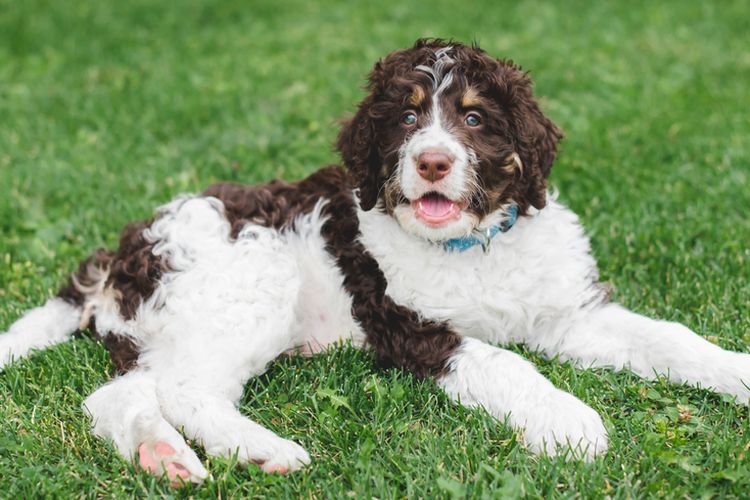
xmin=497 ymin=61 xmax=563 ymax=208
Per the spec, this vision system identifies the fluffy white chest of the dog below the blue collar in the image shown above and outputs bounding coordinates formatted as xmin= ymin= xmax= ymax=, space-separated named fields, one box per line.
xmin=360 ymin=203 xmax=593 ymax=343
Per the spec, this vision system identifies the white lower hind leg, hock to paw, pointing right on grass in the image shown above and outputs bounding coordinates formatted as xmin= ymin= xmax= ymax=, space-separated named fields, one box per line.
xmin=157 ymin=378 xmax=310 ymax=474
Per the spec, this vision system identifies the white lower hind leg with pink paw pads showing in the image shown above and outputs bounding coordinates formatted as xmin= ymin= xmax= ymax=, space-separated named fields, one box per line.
xmin=83 ymin=371 xmax=208 ymax=484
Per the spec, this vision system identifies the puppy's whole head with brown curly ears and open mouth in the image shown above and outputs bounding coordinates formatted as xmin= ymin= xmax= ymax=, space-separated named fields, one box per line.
xmin=337 ymin=40 xmax=562 ymax=241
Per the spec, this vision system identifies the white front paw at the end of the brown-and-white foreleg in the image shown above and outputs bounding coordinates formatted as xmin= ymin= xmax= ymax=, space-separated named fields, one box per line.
xmin=523 ymin=390 xmax=609 ymax=461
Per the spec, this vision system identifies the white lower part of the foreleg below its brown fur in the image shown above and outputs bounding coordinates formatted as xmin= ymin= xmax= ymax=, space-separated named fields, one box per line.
xmin=437 ymin=338 xmax=607 ymax=459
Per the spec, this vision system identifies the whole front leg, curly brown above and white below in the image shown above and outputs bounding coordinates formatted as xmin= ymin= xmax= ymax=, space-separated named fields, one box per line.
xmin=330 ymin=213 xmax=607 ymax=458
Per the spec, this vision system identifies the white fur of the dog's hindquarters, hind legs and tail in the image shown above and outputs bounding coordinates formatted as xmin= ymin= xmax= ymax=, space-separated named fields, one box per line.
xmin=0 ymin=197 xmax=364 ymax=482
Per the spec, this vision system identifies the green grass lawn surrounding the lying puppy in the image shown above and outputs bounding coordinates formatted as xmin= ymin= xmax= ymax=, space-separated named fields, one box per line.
xmin=0 ymin=0 xmax=750 ymax=498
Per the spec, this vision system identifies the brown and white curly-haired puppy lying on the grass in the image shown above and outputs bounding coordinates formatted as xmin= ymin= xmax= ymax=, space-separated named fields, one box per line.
xmin=0 ymin=39 xmax=750 ymax=483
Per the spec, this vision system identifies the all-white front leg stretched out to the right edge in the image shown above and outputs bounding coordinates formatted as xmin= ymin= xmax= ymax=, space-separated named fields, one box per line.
xmin=538 ymin=304 xmax=750 ymax=403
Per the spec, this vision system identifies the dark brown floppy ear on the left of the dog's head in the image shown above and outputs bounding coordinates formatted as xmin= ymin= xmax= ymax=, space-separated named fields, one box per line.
xmin=336 ymin=94 xmax=382 ymax=211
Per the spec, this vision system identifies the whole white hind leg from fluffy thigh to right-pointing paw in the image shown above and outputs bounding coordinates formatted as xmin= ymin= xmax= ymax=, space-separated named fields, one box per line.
xmin=139 ymin=226 xmax=310 ymax=472
